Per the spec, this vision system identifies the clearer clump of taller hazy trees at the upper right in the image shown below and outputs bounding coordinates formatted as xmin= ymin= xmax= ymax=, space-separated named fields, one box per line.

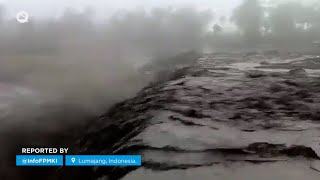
xmin=210 ymin=0 xmax=320 ymax=49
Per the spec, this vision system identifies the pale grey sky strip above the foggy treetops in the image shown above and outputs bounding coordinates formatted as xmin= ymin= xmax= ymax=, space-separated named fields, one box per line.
xmin=0 ymin=0 xmax=241 ymax=18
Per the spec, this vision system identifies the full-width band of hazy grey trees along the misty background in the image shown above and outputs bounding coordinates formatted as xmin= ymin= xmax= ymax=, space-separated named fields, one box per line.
xmin=0 ymin=0 xmax=320 ymax=54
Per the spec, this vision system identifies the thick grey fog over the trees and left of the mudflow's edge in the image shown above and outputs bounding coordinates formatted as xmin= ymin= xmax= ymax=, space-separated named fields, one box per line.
xmin=0 ymin=0 xmax=320 ymax=179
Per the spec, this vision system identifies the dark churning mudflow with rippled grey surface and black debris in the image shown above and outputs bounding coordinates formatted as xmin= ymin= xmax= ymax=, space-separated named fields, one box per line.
xmin=57 ymin=52 xmax=320 ymax=180
